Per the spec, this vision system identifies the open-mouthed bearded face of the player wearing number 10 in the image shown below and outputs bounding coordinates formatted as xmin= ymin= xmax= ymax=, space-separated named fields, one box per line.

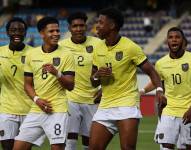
xmin=167 ymin=31 xmax=184 ymax=53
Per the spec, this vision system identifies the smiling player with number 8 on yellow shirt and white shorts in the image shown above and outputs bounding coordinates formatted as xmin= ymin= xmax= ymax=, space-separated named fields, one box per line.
xmin=13 ymin=17 xmax=75 ymax=150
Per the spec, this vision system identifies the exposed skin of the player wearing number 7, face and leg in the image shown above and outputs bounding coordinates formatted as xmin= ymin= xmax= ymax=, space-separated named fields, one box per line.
xmin=1 ymin=21 xmax=31 ymax=150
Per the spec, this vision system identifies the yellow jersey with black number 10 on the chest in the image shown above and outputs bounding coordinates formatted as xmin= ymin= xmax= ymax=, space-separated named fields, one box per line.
xmin=155 ymin=51 xmax=191 ymax=117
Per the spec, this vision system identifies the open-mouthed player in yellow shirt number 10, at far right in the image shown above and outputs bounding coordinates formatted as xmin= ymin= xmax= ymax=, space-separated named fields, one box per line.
xmin=142 ymin=27 xmax=191 ymax=150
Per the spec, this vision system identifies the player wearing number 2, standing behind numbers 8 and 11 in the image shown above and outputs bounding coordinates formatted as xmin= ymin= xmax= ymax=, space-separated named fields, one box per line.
xmin=61 ymin=12 xmax=103 ymax=150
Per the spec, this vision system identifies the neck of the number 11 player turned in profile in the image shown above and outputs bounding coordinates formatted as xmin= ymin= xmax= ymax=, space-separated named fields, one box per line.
xmin=105 ymin=34 xmax=121 ymax=46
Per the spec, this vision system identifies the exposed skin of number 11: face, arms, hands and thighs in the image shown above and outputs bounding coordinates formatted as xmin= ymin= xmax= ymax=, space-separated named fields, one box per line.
xmin=90 ymin=15 xmax=166 ymax=150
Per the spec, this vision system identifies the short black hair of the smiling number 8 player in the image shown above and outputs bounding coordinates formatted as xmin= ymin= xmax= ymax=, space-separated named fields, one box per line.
xmin=37 ymin=16 xmax=59 ymax=32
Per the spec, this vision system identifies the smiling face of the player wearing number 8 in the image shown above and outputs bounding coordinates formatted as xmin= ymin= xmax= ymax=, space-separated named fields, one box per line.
xmin=40 ymin=23 xmax=60 ymax=46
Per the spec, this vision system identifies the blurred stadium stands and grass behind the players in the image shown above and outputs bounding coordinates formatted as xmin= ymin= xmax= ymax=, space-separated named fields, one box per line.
xmin=0 ymin=0 xmax=191 ymax=150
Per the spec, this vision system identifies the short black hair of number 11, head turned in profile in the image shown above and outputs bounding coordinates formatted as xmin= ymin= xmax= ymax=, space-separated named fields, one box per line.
xmin=98 ymin=8 xmax=124 ymax=30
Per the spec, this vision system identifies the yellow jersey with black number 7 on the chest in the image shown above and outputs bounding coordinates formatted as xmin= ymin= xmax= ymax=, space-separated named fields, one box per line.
xmin=0 ymin=45 xmax=33 ymax=115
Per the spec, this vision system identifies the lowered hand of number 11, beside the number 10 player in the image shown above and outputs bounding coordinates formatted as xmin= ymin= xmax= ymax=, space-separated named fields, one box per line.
xmin=156 ymin=91 xmax=167 ymax=118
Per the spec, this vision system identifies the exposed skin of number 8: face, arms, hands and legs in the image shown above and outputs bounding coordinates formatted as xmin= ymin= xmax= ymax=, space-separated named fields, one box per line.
xmin=13 ymin=23 xmax=74 ymax=150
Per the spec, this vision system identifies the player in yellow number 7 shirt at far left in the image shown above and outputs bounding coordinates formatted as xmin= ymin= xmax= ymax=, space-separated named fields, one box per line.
xmin=0 ymin=17 xmax=43 ymax=150
